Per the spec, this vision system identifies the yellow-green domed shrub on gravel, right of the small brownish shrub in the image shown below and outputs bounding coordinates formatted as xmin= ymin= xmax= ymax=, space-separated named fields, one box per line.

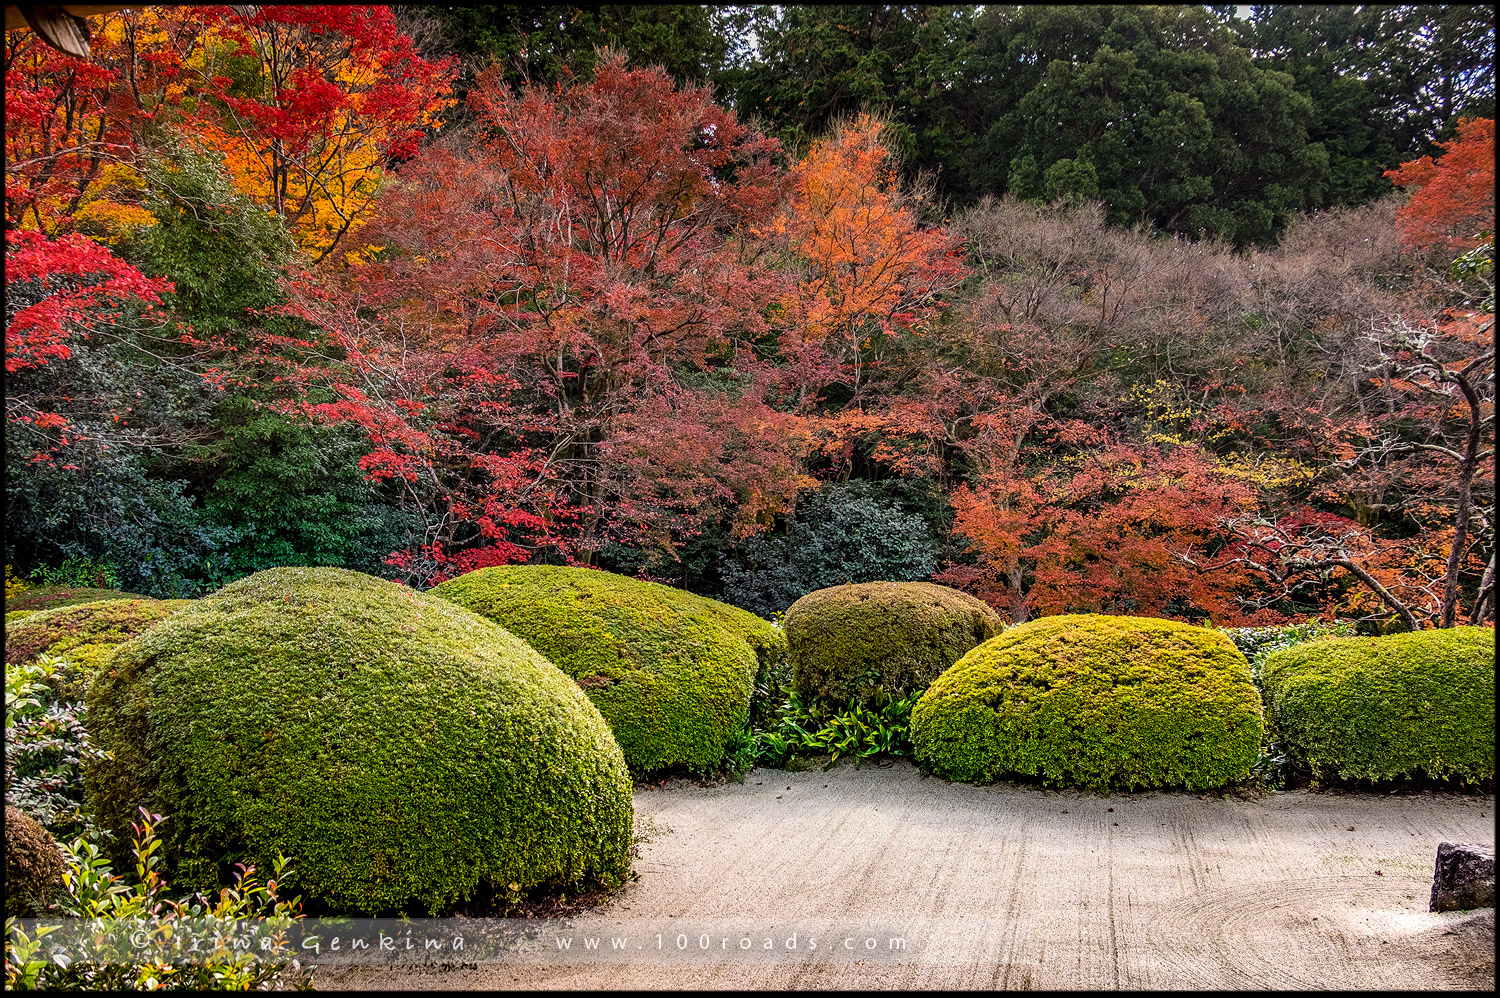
xmin=912 ymin=614 xmax=1262 ymax=789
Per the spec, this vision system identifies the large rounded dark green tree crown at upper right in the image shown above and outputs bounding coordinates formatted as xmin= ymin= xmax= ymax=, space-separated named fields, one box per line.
xmin=975 ymin=6 xmax=1328 ymax=245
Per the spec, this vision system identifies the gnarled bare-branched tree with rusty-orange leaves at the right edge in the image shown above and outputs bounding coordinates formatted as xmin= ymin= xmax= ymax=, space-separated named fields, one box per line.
xmin=1224 ymin=315 xmax=1494 ymax=630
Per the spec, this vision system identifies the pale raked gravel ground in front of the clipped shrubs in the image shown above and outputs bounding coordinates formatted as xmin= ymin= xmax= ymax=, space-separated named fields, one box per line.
xmin=315 ymin=762 xmax=1496 ymax=989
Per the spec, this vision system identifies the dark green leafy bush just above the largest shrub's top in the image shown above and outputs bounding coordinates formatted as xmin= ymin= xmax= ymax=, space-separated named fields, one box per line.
xmin=204 ymin=398 xmax=419 ymax=578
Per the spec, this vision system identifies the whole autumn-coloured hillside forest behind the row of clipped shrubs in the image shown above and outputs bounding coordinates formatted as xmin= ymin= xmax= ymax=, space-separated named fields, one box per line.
xmin=5 ymin=5 xmax=1496 ymax=632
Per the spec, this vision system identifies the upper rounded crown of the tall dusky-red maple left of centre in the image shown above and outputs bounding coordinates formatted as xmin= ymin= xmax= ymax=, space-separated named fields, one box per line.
xmin=369 ymin=52 xmax=779 ymax=390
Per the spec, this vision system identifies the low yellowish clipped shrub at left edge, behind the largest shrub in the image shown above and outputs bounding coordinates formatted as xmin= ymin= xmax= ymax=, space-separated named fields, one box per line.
xmin=5 ymin=599 xmax=192 ymax=699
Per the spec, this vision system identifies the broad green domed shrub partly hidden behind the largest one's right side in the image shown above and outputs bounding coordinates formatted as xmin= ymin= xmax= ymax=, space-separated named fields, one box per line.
xmin=432 ymin=564 xmax=785 ymax=771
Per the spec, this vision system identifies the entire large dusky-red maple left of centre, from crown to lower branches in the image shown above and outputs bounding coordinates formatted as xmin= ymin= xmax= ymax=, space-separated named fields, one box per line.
xmin=277 ymin=56 xmax=798 ymax=579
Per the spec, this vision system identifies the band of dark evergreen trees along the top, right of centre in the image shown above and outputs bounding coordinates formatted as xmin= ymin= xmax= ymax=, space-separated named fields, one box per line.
xmin=720 ymin=5 xmax=1494 ymax=245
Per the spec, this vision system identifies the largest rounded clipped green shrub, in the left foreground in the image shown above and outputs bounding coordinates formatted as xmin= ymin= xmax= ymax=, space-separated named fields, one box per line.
xmin=84 ymin=569 xmax=632 ymax=912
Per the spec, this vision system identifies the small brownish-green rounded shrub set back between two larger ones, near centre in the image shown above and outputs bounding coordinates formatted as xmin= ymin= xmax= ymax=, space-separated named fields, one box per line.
xmin=786 ymin=582 xmax=1005 ymax=704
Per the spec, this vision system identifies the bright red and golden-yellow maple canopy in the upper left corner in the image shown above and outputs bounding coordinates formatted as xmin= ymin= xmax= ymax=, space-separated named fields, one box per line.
xmin=6 ymin=6 xmax=455 ymax=260
